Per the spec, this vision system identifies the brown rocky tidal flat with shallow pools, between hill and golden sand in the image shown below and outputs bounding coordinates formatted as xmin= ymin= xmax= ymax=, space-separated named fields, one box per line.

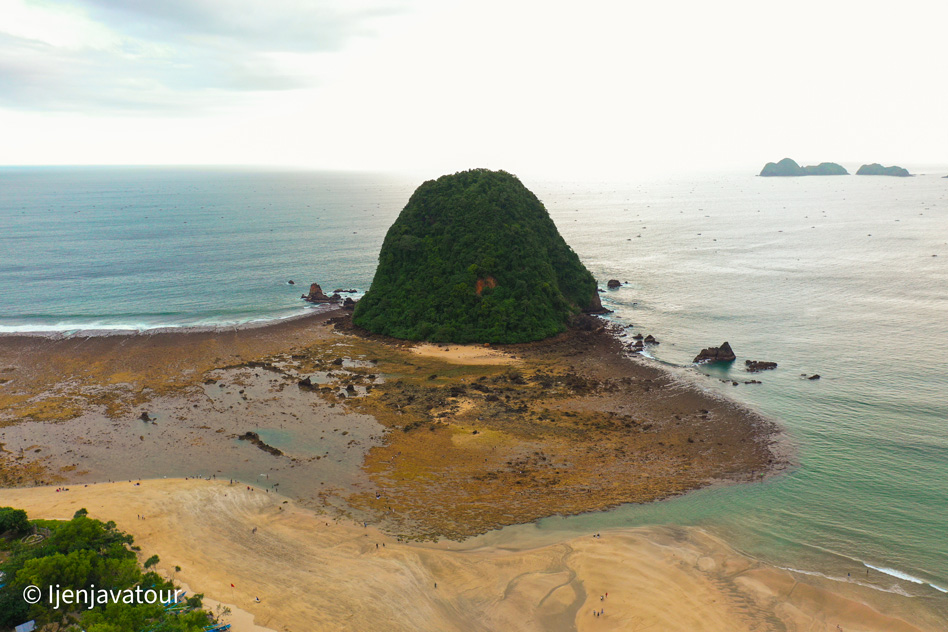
xmin=0 ymin=312 xmax=776 ymax=539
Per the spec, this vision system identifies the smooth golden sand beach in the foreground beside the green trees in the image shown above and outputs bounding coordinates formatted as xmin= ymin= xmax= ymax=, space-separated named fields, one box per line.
xmin=0 ymin=479 xmax=936 ymax=632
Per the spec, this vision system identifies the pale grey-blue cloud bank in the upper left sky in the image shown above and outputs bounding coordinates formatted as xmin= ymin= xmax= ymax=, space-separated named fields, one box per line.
xmin=0 ymin=0 xmax=407 ymax=115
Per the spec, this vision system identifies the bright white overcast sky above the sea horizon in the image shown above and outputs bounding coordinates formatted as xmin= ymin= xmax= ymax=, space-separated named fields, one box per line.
xmin=0 ymin=0 xmax=948 ymax=177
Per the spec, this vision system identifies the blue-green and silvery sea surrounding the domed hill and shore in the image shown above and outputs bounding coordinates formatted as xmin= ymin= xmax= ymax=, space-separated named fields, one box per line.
xmin=0 ymin=165 xmax=948 ymax=612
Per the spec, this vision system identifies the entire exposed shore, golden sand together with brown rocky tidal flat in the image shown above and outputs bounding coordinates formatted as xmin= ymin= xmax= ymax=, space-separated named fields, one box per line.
xmin=0 ymin=312 xmax=937 ymax=632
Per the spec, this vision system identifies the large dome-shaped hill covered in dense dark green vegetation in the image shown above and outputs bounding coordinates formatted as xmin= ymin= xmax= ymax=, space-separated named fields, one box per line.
xmin=353 ymin=169 xmax=603 ymax=343
